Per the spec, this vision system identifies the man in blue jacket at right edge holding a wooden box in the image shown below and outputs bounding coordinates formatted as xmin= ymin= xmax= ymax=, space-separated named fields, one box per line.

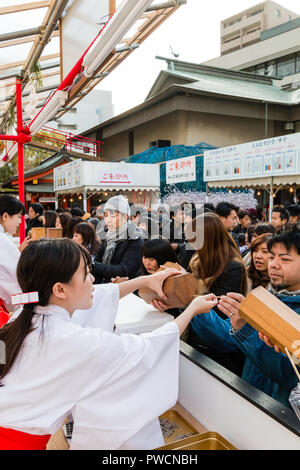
xmin=192 ymin=227 xmax=300 ymax=407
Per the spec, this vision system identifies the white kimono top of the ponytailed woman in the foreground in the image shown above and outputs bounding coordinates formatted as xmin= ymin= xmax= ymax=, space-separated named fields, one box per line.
xmin=0 ymin=284 xmax=179 ymax=450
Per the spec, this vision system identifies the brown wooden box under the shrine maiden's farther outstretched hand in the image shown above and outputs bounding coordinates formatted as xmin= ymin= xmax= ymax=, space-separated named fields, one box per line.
xmin=139 ymin=263 xmax=198 ymax=308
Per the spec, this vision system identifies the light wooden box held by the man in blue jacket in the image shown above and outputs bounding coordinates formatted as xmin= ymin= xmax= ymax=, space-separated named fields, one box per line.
xmin=240 ymin=286 xmax=300 ymax=359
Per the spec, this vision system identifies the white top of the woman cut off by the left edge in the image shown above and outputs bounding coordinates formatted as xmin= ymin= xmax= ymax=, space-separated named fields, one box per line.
xmin=0 ymin=224 xmax=22 ymax=311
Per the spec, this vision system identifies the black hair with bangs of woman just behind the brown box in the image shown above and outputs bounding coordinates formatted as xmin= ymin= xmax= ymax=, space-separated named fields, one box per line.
xmin=141 ymin=238 xmax=179 ymax=276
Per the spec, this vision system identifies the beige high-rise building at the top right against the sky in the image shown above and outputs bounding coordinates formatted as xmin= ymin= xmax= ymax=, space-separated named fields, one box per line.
xmin=221 ymin=0 xmax=298 ymax=55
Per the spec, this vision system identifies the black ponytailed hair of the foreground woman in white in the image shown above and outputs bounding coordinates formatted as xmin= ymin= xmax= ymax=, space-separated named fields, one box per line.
xmin=0 ymin=239 xmax=91 ymax=379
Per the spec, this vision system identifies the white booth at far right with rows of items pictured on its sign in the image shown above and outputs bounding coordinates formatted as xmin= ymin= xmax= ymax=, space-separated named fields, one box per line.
xmin=204 ymin=132 xmax=300 ymax=218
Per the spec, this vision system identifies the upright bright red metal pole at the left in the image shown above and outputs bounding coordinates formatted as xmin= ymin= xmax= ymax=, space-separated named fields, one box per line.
xmin=16 ymin=78 xmax=25 ymax=243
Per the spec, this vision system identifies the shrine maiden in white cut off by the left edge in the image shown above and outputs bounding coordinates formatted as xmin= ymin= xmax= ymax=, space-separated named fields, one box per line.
xmin=0 ymin=195 xmax=25 ymax=316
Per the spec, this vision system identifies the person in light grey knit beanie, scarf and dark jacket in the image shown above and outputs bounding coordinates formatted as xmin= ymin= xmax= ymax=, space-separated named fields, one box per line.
xmin=92 ymin=196 xmax=144 ymax=284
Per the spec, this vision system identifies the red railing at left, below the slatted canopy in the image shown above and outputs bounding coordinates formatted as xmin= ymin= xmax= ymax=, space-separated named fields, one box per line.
xmin=33 ymin=126 xmax=103 ymax=160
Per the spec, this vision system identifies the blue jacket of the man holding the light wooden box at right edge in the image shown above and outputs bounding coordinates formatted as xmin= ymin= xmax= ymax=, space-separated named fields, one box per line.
xmin=191 ymin=295 xmax=300 ymax=407
